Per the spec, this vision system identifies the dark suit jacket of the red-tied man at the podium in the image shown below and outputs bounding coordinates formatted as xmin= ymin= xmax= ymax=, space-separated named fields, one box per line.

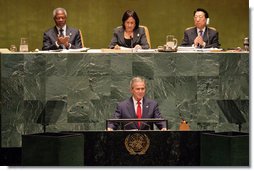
xmin=108 ymin=97 xmax=166 ymax=130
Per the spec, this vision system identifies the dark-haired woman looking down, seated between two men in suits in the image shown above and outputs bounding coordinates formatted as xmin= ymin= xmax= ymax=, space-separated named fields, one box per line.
xmin=109 ymin=10 xmax=149 ymax=49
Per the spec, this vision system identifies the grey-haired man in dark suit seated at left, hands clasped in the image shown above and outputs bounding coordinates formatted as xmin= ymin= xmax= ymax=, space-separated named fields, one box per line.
xmin=42 ymin=8 xmax=82 ymax=50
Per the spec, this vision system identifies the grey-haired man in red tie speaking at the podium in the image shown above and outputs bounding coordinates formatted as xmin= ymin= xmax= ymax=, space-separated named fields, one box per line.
xmin=107 ymin=77 xmax=166 ymax=131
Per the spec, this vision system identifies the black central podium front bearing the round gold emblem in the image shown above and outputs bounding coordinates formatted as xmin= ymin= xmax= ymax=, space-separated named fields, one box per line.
xmin=64 ymin=130 xmax=212 ymax=166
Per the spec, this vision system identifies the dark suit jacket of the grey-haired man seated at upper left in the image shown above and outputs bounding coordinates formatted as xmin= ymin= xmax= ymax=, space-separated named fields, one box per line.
xmin=42 ymin=26 xmax=82 ymax=50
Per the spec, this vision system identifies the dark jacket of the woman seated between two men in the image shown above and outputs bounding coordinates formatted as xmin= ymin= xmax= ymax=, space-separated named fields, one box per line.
xmin=109 ymin=26 xmax=149 ymax=49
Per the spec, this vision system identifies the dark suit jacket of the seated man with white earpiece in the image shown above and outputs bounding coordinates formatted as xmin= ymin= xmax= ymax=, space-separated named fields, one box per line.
xmin=181 ymin=27 xmax=220 ymax=48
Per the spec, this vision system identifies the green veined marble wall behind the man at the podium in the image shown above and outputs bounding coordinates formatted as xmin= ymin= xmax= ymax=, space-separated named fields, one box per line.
xmin=1 ymin=53 xmax=249 ymax=147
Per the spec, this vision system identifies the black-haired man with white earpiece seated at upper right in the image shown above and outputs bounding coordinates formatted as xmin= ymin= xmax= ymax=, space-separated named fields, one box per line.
xmin=181 ymin=8 xmax=220 ymax=48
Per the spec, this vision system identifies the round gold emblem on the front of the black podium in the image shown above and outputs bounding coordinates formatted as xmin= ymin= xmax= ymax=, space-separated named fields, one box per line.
xmin=125 ymin=133 xmax=150 ymax=155
